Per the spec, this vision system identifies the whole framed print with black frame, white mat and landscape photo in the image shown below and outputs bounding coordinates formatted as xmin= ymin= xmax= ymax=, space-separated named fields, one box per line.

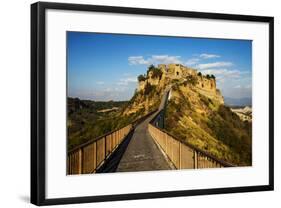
xmin=31 ymin=2 xmax=274 ymax=205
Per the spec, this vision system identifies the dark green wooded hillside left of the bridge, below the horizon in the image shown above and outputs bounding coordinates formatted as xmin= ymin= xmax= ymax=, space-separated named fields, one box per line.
xmin=67 ymin=98 xmax=143 ymax=150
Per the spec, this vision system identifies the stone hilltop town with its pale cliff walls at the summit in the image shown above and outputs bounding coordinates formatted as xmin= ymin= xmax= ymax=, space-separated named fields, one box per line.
xmin=122 ymin=64 xmax=224 ymax=115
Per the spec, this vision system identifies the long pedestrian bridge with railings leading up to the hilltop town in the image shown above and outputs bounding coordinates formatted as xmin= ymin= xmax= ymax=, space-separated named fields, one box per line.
xmin=67 ymin=86 xmax=233 ymax=174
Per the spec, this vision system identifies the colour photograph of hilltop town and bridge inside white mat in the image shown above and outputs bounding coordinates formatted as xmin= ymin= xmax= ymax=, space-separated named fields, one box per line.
xmin=66 ymin=31 xmax=254 ymax=175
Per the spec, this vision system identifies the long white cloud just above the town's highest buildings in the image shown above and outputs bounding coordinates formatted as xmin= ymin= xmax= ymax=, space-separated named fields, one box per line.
xmin=128 ymin=55 xmax=182 ymax=65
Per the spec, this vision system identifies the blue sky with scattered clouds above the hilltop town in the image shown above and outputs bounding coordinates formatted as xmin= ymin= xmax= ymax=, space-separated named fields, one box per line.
xmin=67 ymin=32 xmax=252 ymax=101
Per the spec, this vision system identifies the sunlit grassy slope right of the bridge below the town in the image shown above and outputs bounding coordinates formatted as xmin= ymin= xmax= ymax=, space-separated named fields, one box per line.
xmin=163 ymin=84 xmax=252 ymax=165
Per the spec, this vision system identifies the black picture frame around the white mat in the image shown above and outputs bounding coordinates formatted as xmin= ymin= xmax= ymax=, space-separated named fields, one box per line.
xmin=31 ymin=2 xmax=274 ymax=205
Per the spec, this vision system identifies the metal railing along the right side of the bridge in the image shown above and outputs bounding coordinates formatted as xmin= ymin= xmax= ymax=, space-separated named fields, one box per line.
xmin=148 ymin=111 xmax=234 ymax=169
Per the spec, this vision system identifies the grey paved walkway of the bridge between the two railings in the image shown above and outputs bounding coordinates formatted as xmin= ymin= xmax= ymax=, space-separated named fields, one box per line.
xmin=116 ymin=113 xmax=171 ymax=172
